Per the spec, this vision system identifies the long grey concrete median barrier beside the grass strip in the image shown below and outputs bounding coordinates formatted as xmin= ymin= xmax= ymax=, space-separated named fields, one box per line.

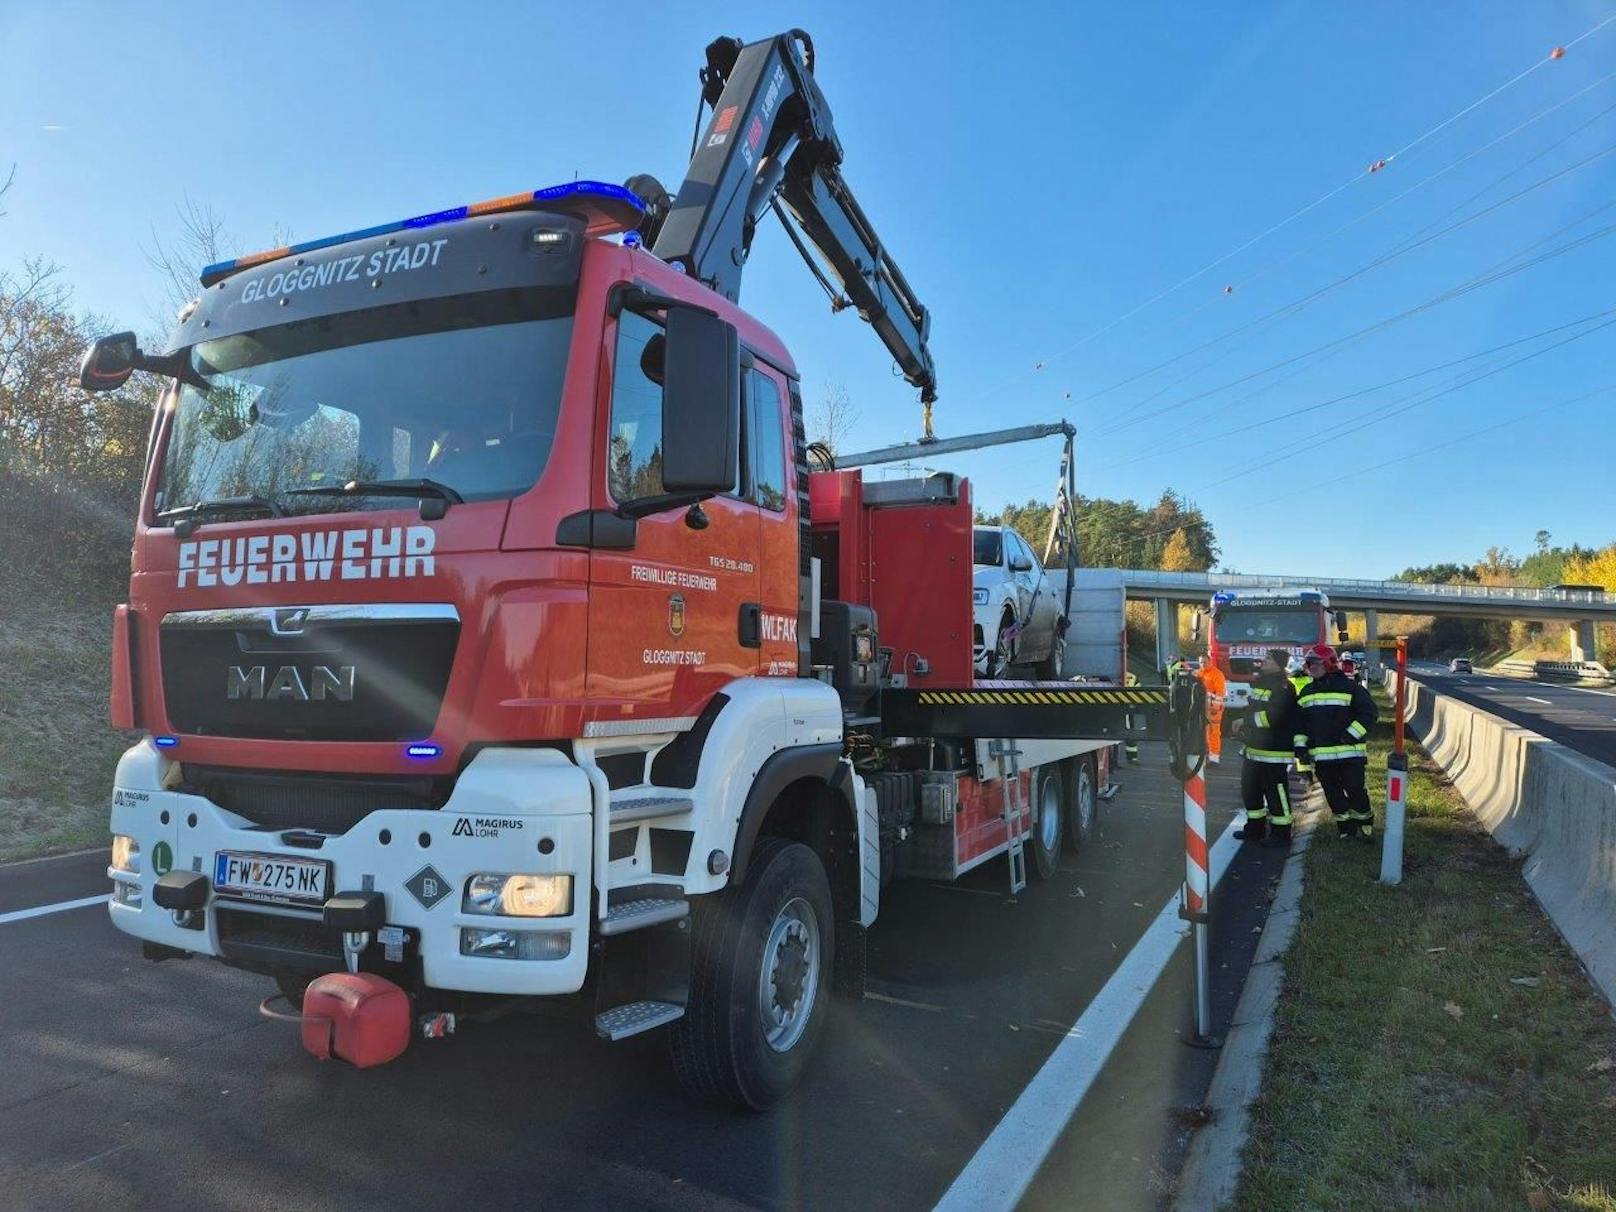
xmin=1387 ymin=674 xmax=1616 ymax=1002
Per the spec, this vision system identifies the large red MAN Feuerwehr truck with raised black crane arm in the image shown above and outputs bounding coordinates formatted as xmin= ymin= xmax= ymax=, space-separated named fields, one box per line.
xmin=81 ymin=31 xmax=1167 ymax=1107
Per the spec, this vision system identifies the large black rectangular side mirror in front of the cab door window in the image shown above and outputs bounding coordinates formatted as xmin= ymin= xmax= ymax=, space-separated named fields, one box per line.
xmin=663 ymin=307 xmax=740 ymax=493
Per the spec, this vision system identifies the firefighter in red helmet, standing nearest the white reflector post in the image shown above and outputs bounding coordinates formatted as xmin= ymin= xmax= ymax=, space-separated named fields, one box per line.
xmin=1291 ymin=643 xmax=1380 ymax=842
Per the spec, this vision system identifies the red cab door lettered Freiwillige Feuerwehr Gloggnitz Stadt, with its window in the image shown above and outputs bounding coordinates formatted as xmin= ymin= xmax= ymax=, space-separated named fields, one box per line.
xmin=587 ymin=310 xmax=761 ymax=716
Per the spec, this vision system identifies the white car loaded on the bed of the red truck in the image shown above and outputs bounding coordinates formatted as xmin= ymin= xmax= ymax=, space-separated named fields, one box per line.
xmin=971 ymin=527 xmax=1063 ymax=679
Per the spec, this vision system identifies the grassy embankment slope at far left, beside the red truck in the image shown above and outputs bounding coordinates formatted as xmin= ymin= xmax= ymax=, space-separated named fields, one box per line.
xmin=0 ymin=593 xmax=129 ymax=861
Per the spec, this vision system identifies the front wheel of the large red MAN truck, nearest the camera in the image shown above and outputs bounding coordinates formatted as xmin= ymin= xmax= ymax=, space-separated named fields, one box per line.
xmin=672 ymin=837 xmax=835 ymax=1110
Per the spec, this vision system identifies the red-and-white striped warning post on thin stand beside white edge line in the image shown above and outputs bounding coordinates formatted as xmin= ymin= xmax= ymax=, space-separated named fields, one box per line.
xmin=1168 ymin=674 xmax=1223 ymax=1047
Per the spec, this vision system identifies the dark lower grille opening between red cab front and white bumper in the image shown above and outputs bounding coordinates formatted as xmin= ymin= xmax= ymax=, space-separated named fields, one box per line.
xmin=181 ymin=764 xmax=451 ymax=834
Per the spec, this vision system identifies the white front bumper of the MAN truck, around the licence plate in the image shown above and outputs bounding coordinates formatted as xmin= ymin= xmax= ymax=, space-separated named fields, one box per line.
xmin=108 ymin=742 xmax=593 ymax=994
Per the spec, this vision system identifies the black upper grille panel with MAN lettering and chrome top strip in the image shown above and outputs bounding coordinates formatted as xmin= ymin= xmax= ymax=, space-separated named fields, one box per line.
xmin=162 ymin=604 xmax=461 ymax=740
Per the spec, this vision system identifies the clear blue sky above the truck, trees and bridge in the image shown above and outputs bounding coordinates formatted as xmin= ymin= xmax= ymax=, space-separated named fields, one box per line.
xmin=0 ymin=0 xmax=1616 ymax=575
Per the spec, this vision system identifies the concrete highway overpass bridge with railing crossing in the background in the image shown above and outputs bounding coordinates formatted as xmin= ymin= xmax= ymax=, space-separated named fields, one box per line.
xmin=1052 ymin=569 xmax=1616 ymax=667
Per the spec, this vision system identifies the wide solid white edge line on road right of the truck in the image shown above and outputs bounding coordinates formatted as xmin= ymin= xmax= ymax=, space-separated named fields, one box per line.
xmin=937 ymin=821 xmax=1239 ymax=1212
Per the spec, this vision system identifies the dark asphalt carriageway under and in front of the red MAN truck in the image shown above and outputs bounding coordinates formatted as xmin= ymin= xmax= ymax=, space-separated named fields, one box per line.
xmin=0 ymin=759 xmax=1280 ymax=1212
